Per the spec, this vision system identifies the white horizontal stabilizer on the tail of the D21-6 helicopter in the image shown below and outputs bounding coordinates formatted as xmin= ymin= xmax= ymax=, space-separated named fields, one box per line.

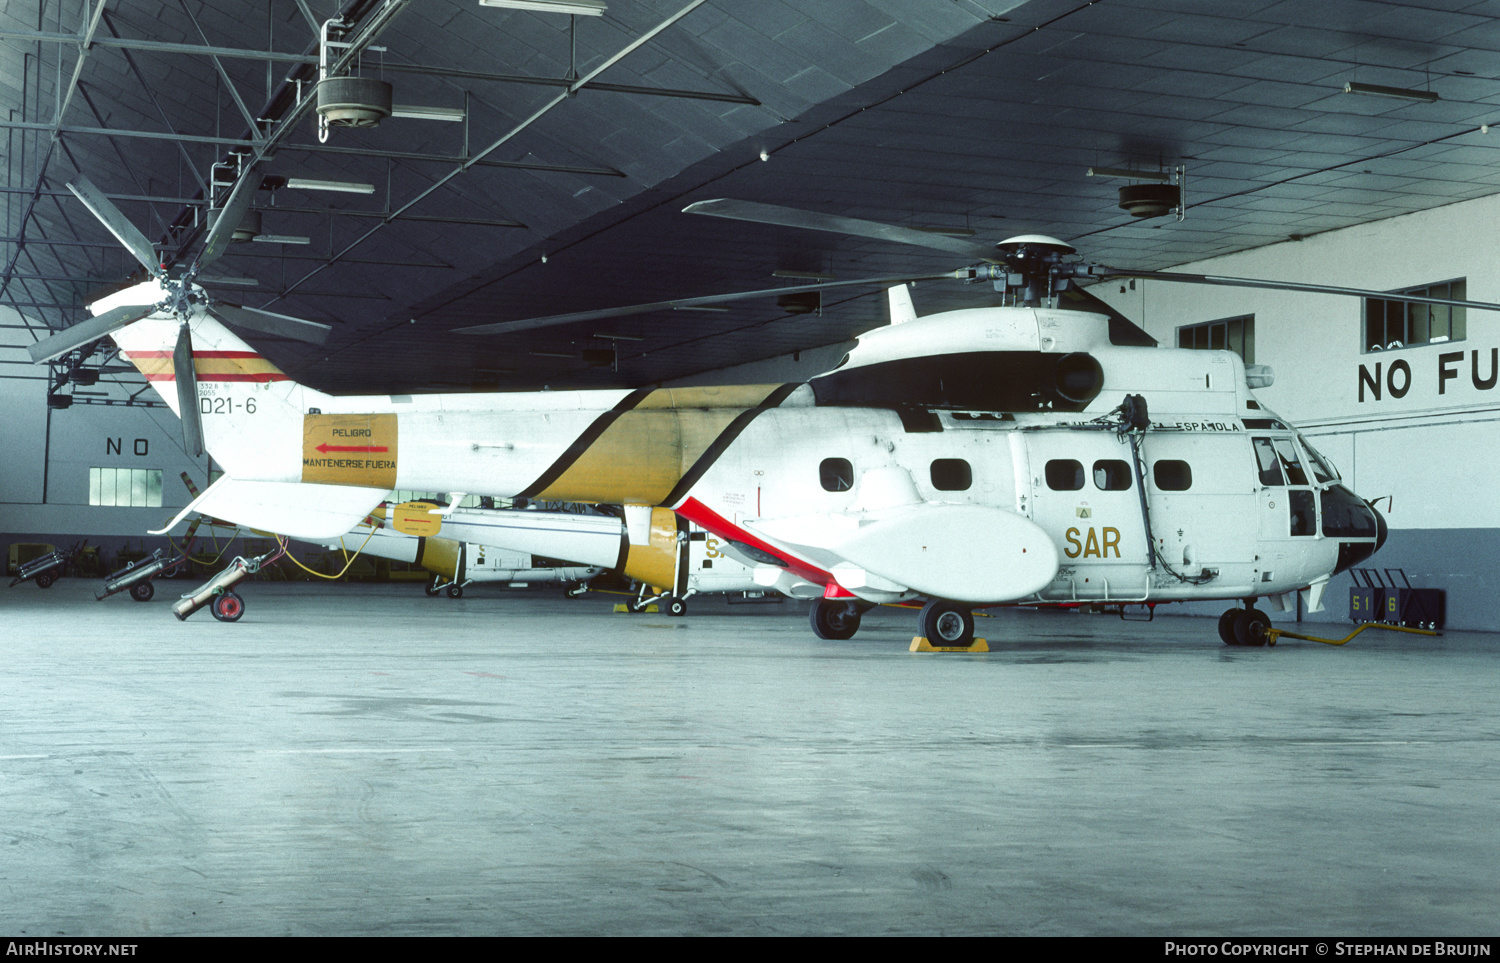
xmin=152 ymin=476 xmax=389 ymax=542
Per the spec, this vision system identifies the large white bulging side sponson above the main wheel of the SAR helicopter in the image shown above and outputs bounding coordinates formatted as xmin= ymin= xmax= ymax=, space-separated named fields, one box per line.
xmin=746 ymin=503 xmax=1058 ymax=603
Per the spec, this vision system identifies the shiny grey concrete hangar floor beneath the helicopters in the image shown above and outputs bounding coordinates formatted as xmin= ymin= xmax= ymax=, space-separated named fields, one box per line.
xmin=0 ymin=581 xmax=1500 ymax=938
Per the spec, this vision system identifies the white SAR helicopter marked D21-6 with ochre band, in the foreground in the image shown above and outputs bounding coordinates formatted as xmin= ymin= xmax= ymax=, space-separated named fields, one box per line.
xmin=41 ymin=181 xmax=1482 ymax=647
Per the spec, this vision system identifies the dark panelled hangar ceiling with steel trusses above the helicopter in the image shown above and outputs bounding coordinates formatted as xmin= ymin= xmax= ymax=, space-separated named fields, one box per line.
xmin=0 ymin=0 xmax=1500 ymax=399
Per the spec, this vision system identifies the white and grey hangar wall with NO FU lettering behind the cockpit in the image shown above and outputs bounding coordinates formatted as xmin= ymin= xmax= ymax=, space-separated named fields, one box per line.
xmin=1094 ymin=197 xmax=1500 ymax=632
